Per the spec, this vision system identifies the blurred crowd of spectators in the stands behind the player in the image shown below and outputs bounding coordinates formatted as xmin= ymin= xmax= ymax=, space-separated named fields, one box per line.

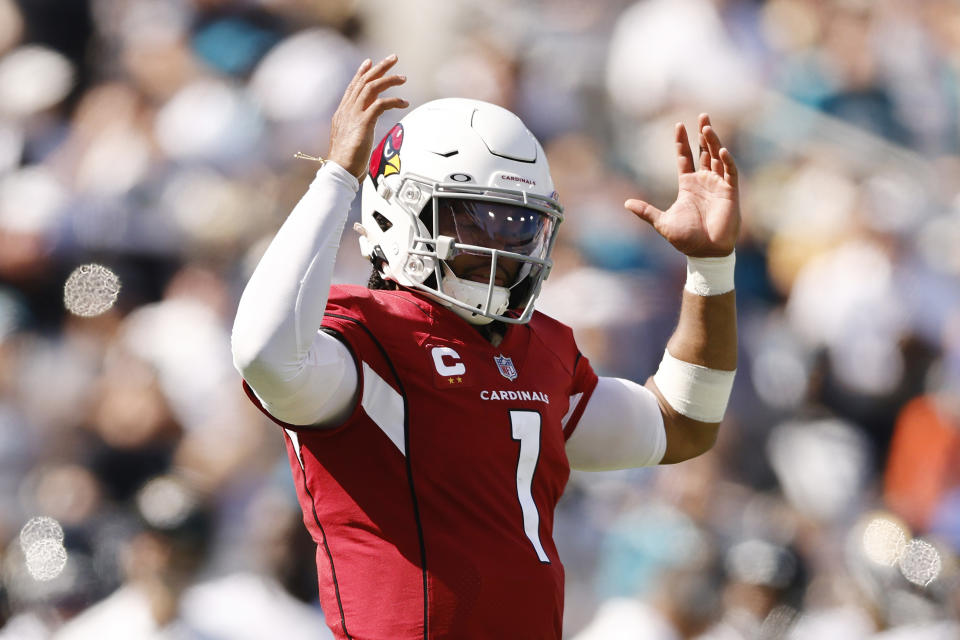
xmin=0 ymin=0 xmax=960 ymax=640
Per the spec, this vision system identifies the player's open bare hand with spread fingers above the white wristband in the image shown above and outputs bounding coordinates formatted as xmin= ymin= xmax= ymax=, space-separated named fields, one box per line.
xmin=624 ymin=113 xmax=740 ymax=258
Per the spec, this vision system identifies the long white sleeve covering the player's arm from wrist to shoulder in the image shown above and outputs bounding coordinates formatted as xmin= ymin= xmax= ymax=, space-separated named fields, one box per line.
xmin=231 ymin=162 xmax=359 ymax=426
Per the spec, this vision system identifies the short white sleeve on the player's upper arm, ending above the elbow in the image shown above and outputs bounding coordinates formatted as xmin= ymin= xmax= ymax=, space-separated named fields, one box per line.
xmin=567 ymin=377 xmax=667 ymax=471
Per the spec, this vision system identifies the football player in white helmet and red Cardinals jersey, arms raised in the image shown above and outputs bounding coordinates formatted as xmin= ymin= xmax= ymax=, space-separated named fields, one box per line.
xmin=233 ymin=56 xmax=740 ymax=640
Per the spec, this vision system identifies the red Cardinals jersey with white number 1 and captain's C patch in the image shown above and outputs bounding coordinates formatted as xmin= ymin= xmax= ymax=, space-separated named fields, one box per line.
xmin=244 ymin=286 xmax=597 ymax=640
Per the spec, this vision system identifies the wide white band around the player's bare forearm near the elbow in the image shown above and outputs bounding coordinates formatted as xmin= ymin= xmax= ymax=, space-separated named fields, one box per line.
xmin=653 ymin=349 xmax=737 ymax=422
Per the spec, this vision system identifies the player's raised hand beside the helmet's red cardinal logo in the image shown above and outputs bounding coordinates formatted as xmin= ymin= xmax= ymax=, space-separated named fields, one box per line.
xmin=327 ymin=54 xmax=410 ymax=181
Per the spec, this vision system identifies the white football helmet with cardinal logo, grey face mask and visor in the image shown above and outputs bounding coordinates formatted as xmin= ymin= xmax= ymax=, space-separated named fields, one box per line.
xmin=356 ymin=98 xmax=563 ymax=324
